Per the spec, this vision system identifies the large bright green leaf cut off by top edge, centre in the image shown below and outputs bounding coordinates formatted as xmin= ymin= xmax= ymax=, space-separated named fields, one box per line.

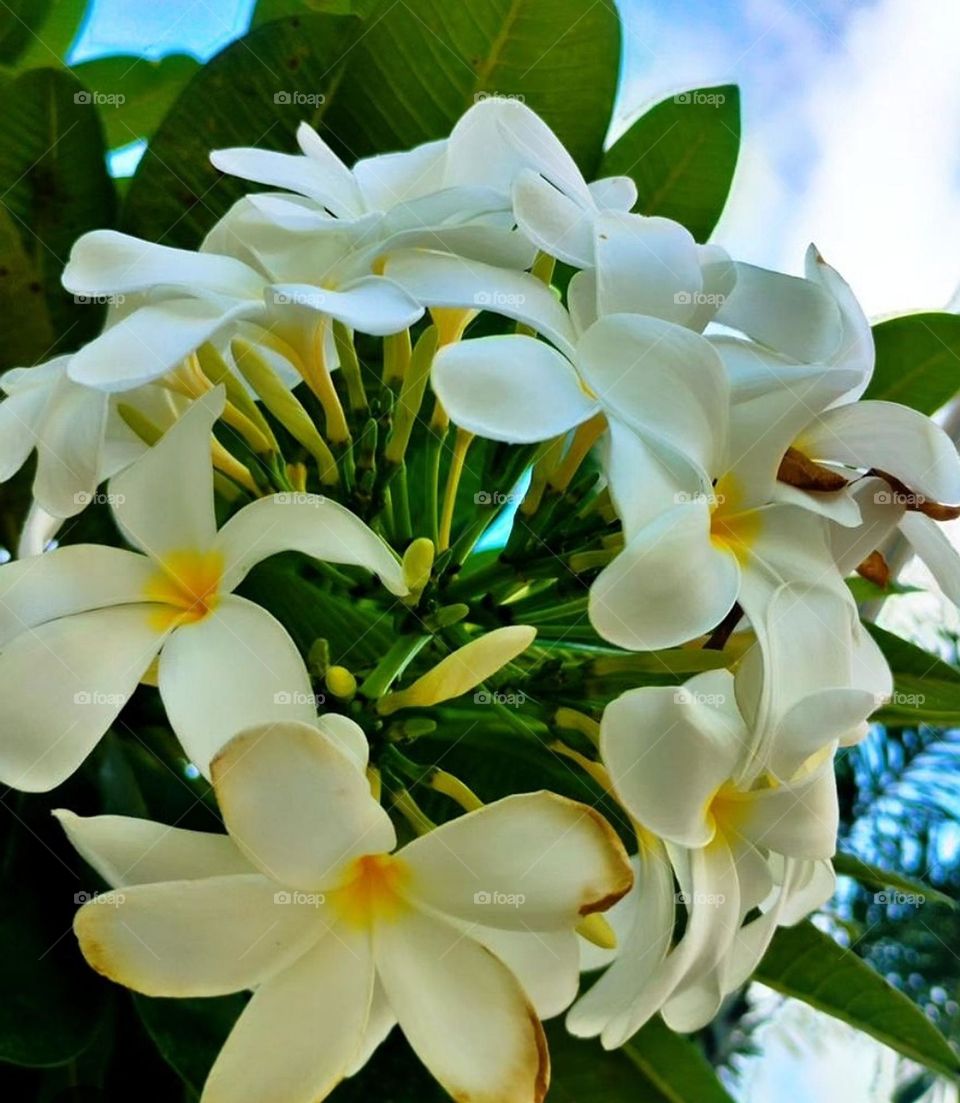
xmin=324 ymin=0 xmax=620 ymax=172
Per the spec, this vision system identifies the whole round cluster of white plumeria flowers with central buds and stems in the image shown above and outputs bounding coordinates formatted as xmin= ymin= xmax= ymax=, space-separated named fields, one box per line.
xmin=0 ymin=97 xmax=960 ymax=1103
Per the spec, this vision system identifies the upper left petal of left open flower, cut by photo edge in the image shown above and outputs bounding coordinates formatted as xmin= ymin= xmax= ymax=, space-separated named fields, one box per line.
xmin=0 ymin=544 xmax=156 ymax=647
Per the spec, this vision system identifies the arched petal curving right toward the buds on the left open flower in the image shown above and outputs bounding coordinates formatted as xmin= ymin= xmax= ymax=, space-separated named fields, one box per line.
xmin=216 ymin=494 xmax=407 ymax=597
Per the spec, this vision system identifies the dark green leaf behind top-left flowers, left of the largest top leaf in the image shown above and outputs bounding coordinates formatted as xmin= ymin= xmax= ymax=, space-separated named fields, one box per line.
xmin=122 ymin=15 xmax=362 ymax=248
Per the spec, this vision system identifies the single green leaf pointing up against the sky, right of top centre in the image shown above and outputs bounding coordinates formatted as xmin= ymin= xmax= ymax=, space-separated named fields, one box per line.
xmin=598 ymin=84 xmax=740 ymax=242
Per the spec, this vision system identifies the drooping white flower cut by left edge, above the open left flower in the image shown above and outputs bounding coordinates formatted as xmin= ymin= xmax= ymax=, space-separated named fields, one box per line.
xmin=0 ymin=356 xmax=113 ymax=518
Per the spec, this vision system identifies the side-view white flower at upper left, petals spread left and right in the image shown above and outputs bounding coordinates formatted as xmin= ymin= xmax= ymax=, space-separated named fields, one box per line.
xmin=63 ymin=223 xmax=423 ymax=390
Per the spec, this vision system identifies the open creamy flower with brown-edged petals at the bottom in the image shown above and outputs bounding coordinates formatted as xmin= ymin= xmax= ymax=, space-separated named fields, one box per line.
xmin=60 ymin=717 xmax=631 ymax=1103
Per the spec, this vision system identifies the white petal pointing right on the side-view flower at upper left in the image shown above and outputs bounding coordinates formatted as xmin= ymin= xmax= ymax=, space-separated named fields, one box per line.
xmin=268 ymin=276 xmax=424 ymax=338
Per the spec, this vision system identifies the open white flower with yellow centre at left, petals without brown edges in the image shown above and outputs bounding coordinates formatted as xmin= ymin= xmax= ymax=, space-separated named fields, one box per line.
xmin=0 ymin=388 xmax=407 ymax=791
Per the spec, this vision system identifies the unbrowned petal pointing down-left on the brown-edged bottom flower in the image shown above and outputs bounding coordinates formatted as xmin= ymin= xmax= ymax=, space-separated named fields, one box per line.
xmin=201 ymin=930 xmax=374 ymax=1103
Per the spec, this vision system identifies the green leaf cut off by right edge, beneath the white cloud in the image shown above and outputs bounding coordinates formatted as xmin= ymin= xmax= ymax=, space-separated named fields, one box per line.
xmin=864 ymin=313 xmax=960 ymax=414
